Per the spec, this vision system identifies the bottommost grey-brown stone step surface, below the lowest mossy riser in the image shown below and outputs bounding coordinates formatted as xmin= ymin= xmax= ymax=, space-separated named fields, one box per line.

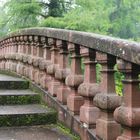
xmin=0 ymin=126 xmax=72 ymax=140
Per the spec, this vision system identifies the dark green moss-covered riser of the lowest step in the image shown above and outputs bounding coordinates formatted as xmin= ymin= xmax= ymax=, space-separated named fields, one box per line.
xmin=0 ymin=111 xmax=57 ymax=127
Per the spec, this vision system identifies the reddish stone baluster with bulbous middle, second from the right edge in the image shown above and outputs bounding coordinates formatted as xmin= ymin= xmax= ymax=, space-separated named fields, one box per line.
xmin=94 ymin=53 xmax=121 ymax=140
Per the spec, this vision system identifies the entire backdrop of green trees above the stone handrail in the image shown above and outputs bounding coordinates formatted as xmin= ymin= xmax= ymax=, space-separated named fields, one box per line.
xmin=0 ymin=0 xmax=140 ymax=41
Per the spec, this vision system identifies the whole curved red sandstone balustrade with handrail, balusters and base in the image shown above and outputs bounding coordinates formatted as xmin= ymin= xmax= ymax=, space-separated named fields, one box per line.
xmin=0 ymin=28 xmax=140 ymax=140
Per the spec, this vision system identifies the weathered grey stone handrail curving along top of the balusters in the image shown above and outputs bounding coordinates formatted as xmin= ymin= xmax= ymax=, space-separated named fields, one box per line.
xmin=0 ymin=27 xmax=140 ymax=65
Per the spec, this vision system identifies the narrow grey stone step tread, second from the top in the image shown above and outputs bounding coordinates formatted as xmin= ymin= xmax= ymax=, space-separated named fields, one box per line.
xmin=0 ymin=89 xmax=38 ymax=96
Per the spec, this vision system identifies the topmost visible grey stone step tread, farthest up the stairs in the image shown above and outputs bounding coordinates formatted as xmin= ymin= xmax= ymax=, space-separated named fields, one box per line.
xmin=0 ymin=74 xmax=25 ymax=81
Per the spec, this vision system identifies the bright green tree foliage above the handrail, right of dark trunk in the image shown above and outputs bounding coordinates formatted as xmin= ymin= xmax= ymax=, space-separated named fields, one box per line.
xmin=40 ymin=0 xmax=140 ymax=41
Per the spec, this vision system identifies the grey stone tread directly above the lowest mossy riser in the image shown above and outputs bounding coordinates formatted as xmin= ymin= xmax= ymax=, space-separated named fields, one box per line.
xmin=0 ymin=104 xmax=52 ymax=116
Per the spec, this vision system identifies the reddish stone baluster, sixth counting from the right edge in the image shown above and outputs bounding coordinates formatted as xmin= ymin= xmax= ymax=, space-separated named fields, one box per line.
xmin=47 ymin=38 xmax=60 ymax=96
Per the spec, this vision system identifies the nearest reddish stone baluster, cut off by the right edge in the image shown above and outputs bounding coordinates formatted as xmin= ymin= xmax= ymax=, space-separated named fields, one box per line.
xmin=114 ymin=60 xmax=140 ymax=140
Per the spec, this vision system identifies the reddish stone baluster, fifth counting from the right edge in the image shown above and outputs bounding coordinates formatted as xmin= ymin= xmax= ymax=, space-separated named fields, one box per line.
xmin=55 ymin=40 xmax=70 ymax=104
